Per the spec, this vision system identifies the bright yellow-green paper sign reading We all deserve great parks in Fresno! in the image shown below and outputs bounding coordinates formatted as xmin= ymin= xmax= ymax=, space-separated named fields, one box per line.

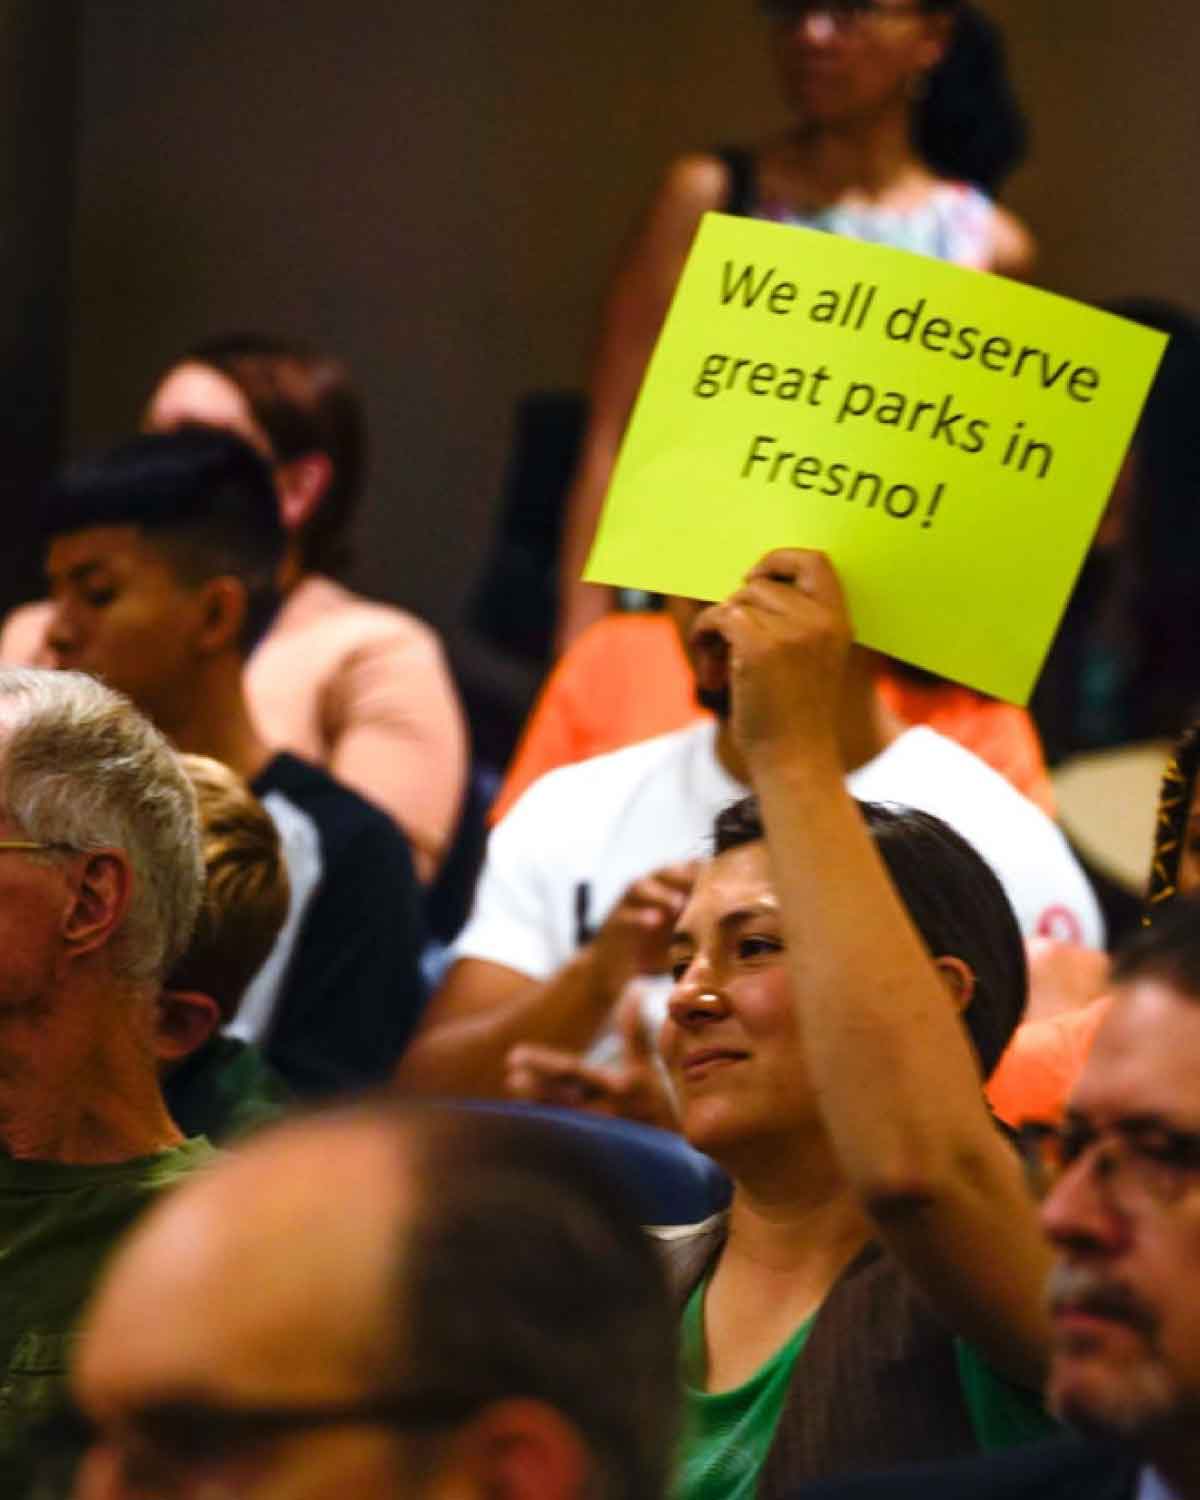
xmin=584 ymin=213 xmax=1166 ymax=704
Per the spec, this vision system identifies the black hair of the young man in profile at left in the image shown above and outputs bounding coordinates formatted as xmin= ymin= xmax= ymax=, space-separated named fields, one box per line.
xmin=39 ymin=428 xmax=285 ymax=651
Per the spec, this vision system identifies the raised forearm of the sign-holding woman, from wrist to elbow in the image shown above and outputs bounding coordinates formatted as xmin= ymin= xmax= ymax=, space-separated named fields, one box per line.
xmin=752 ymin=750 xmax=992 ymax=1199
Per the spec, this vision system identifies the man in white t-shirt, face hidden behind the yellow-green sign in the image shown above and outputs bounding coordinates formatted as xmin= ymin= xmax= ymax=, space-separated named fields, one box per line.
xmin=398 ymin=600 xmax=1104 ymax=1095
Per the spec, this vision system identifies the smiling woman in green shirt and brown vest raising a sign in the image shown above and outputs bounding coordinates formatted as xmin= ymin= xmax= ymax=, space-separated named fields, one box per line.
xmin=659 ymin=552 xmax=1050 ymax=1500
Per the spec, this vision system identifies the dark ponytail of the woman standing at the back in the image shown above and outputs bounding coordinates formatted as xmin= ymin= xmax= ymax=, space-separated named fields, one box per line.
xmin=912 ymin=0 xmax=1029 ymax=194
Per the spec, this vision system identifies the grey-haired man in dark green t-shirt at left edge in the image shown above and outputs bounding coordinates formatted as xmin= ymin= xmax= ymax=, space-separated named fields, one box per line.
xmin=0 ymin=669 xmax=212 ymax=1497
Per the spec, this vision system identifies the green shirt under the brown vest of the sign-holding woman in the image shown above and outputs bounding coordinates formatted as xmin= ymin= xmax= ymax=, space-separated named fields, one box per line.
xmin=672 ymin=1280 xmax=1059 ymax=1500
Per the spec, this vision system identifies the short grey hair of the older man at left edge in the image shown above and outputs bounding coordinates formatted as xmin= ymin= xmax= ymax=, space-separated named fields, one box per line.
xmin=0 ymin=668 xmax=204 ymax=984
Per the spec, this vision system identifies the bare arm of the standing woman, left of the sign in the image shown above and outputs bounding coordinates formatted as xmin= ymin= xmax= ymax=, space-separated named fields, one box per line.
xmin=558 ymin=156 xmax=729 ymax=650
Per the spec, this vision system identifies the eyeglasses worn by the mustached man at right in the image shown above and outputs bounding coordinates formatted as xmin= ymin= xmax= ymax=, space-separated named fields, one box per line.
xmin=1017 ymin=1118 xmax=1200 ymax=1209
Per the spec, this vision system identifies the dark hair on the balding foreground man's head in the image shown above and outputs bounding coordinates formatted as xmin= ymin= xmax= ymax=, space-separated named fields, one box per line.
xmin=396 ymin=1110 xmax=678 ymax=1500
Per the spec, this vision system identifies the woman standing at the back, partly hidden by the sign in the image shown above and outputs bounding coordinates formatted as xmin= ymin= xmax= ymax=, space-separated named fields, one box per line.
xmin=558 ymin=0 xmax=1034 ymax=650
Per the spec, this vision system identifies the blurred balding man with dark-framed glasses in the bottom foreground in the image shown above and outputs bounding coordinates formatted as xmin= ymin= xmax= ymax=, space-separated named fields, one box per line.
xmin=75 ymin=1106 xmax=677 ymax=1500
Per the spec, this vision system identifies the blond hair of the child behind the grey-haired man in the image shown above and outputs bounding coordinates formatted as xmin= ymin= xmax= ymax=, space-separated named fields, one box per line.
xmin=167 ymin=755 xmax=290 ymax=1026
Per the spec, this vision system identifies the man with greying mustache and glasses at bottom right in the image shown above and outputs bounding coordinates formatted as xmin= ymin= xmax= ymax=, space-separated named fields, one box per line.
xmin=786 ymin=897 xmax=1200 ymax=1500
